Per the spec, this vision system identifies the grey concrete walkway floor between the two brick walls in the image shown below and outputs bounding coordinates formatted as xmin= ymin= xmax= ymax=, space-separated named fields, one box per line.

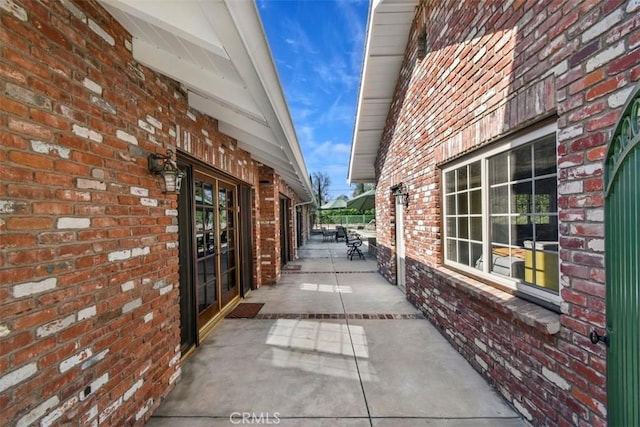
xmin=147 ymin=236 xmax=525 ymax=427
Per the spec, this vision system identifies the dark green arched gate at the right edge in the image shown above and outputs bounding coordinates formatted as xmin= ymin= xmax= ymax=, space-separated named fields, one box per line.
xmin=605 ymin=85 xmax=640 ymax=426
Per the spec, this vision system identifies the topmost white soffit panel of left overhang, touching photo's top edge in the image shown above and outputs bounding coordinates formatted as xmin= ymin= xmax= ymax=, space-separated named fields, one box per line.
xmin=100 ymin=0 xmax=229 ymax=59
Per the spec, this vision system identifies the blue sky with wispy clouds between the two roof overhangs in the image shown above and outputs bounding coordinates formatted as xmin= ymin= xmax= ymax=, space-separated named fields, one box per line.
xmin=257 ymin=0 xmax=369 ymax=198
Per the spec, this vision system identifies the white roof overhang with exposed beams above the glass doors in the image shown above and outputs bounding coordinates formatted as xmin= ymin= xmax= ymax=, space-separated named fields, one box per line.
xmin=100 ymin=0 xmax=314 ymax=202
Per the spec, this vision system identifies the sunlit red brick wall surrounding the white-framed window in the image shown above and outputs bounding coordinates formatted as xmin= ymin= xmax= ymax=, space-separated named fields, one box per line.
xmin=376 ymin=1 xmax=640 ymax=425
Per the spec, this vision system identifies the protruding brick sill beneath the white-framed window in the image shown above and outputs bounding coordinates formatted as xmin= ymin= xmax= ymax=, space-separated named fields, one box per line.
xmin=434 ymin=266 xmax=560 ymax=335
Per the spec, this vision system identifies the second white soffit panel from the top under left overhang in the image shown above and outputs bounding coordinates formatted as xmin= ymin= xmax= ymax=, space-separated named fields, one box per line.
xmin=132 ymin=38 xmax=262 ymax=118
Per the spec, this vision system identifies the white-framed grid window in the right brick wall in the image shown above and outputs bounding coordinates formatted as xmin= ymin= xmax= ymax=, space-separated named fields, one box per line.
xmin=442 ymin=124 xmax=561 ymax=306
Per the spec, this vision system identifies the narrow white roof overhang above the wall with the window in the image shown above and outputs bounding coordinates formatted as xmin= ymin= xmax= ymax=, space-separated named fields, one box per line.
xmin=347 ymin=0 xmax=418 ymax=183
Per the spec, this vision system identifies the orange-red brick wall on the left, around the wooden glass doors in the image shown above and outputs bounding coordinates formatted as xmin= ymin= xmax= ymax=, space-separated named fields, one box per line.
xmin=0 ymin=0 xmax=277 ymax=425
